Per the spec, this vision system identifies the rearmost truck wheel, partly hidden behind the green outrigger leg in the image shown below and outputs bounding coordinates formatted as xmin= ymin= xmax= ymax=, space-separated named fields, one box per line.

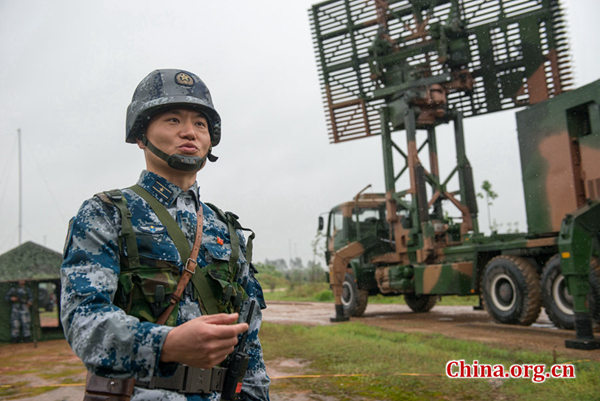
xmin=542 ymin=255 xmax=575 ymax=330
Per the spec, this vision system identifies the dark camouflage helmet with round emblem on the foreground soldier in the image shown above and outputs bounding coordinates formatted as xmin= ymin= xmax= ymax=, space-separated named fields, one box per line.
xmin=125 ymin=69 xmax=221 ymax=146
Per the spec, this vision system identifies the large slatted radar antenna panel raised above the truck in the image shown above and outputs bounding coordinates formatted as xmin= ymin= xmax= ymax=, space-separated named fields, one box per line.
xmin=309 ymin=0 xmax=572 ymax=143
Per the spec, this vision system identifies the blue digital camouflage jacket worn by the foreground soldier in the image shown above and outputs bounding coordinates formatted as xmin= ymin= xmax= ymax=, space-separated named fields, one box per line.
xmin=61 ymin=171 xmax=270 ymax=401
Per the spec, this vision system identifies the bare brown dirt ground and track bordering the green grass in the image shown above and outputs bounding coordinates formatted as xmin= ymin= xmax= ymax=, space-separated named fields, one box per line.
xmin=0 ymin=302 xmax=600 ymax=401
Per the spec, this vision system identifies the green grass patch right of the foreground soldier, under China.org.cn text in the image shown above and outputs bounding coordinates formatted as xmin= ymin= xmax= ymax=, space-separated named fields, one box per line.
xmin=261 ymin=322 xmax=600 ymax=401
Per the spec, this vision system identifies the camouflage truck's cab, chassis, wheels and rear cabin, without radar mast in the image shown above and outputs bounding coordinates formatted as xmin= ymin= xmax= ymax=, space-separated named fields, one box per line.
xmin=320 ymin=80 xmax=600 ymax=329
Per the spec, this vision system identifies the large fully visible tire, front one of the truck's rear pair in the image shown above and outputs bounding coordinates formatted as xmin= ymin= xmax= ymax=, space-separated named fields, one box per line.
xmin=482 ymin=255 xmax=542 ymax=326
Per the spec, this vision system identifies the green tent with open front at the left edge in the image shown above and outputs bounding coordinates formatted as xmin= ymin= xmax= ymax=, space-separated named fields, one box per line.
xmin=0 ymin=241 xmax=63 ymax=342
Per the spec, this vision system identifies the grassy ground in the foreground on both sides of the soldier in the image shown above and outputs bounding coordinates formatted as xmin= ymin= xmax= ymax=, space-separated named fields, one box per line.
xmin=0 ymin=322 xmax=600 ymax=401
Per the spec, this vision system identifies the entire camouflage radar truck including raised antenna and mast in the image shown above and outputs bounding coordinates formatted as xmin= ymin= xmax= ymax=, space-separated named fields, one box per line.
xmin=309 ymin=0 xmax=600 ymax=348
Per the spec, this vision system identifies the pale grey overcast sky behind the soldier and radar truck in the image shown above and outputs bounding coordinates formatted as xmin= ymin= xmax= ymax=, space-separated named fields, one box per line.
xmin=0 ymin=0 xmax=600 ymax=262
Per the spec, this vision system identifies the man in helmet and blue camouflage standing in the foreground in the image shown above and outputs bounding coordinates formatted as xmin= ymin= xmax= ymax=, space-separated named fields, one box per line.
xmin=61 ymin=70 xmax=270 ymax=401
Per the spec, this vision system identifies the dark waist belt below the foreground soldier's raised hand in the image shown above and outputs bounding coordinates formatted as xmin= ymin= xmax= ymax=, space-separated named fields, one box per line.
xmin=135 ymin=365 xmax=227 ymax=393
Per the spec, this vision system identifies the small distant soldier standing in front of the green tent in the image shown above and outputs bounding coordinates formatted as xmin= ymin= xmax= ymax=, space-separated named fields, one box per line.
xmin=5 ymin=280 xmax=33 ymax=343
